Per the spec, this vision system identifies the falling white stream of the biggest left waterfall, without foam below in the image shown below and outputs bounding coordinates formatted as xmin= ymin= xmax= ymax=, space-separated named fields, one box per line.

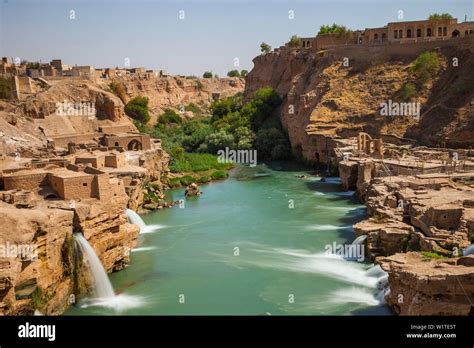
xmin=74 ymin=233 xmax=115 ymax=298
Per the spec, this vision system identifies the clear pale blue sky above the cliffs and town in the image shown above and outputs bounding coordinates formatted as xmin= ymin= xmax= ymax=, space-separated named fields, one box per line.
xmin=0 ymin=0 xmax=474 ymax=76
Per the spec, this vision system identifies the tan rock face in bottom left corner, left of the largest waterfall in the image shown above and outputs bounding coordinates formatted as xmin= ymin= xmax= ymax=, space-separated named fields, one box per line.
xmin=0 ymin=204 xmax=74 ymax=315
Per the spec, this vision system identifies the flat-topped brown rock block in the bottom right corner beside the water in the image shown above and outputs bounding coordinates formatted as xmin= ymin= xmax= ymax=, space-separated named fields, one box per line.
xmin=377 ymin=252 xmax=474 ymax=315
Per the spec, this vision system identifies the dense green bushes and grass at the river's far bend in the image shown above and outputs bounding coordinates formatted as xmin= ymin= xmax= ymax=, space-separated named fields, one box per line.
xmin=136 ymin=88 xmax=291 ymax=172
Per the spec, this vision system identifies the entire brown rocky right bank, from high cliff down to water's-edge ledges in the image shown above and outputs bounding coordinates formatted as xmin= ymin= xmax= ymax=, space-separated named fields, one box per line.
xmin=244 ymin=37 xmax=474 ymax=315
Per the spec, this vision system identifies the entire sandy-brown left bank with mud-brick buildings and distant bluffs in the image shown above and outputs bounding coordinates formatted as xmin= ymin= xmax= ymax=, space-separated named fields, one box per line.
xmin=0 ymin=72 xmax=244 ymax=315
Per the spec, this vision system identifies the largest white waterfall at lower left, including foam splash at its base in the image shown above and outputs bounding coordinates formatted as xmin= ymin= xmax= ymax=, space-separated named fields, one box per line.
xmin=74 ymin=233 xmax=143 ymax=311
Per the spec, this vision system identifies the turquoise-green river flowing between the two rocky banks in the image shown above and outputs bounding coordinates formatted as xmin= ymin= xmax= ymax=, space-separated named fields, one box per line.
xmin=66 ymin=164 xmax=389 ymax=315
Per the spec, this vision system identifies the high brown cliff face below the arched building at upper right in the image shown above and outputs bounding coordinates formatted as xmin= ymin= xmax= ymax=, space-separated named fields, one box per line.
xmin=244 ymin=40 xmax=474 ymax=161
